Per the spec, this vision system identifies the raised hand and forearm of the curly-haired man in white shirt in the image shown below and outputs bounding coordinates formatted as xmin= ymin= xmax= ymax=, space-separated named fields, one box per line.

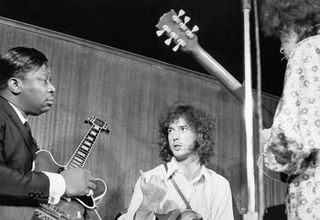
xmin=134 ymin=171 xmax=167 ymax=220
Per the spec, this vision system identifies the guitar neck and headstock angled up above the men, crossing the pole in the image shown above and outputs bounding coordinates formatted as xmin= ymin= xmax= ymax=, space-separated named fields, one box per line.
xmin=156 ymin=10 xmax=273 ymax=127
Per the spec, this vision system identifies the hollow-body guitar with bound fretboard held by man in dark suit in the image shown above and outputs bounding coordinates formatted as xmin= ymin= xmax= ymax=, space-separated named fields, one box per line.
xmin=0 ymin=116 xmax=110 ymax=220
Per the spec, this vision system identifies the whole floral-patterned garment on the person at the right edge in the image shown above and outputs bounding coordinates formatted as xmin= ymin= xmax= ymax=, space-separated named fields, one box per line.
xmin=264 ymin=35 xmax=320 ymax=220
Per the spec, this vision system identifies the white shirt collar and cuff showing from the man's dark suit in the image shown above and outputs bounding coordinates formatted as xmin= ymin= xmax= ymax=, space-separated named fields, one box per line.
xmin=9 ymin=102 xmax=66 ymax=205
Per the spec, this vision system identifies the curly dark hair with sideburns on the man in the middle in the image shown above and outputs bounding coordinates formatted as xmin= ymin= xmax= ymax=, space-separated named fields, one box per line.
xmin=159 ymin=103 xmax=216 ymax=164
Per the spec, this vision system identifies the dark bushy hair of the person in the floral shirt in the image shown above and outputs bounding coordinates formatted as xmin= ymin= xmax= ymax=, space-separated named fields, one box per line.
xmin=261 ymin=0 xmax=320 ymax=40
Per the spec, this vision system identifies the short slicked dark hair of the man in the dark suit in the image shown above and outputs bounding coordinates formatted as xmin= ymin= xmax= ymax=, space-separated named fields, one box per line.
xmin=0 ymin=47 xmax=48 ymax=90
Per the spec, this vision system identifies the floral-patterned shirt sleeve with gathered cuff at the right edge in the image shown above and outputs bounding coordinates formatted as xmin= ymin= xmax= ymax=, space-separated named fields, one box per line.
xmin=264 ymin=38 xmax=320 ymax=174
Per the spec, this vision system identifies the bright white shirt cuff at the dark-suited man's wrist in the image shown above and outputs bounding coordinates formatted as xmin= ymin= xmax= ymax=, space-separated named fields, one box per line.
xmin=43 ymin=171 xmax=66 ymax=205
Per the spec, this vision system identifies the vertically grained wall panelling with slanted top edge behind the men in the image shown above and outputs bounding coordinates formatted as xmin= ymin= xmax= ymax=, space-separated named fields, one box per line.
xmin=0 ymin=18 xmax=284 ymax=219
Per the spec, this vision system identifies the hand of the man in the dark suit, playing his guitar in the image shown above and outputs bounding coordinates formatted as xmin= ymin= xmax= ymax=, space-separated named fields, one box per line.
xmin=61 ymin=168 xmax=96 ymax=197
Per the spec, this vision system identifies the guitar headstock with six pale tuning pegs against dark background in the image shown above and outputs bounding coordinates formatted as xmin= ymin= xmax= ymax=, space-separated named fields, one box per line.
xmin=156 ymin=10 xmax=199 ymax=52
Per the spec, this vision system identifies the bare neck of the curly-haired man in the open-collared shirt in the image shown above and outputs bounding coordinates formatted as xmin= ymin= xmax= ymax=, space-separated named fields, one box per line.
xmin=177 ymin=155 xmax=201 ymax=181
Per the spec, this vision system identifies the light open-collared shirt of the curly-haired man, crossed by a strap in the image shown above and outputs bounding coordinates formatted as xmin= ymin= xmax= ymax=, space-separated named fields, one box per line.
xmin=120 ymin=158 xmax=234 ymax=220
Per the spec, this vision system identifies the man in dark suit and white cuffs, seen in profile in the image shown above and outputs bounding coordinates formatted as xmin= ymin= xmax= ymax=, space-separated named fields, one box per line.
xmin=0 ymin=47 xmax=96 ymax=217
